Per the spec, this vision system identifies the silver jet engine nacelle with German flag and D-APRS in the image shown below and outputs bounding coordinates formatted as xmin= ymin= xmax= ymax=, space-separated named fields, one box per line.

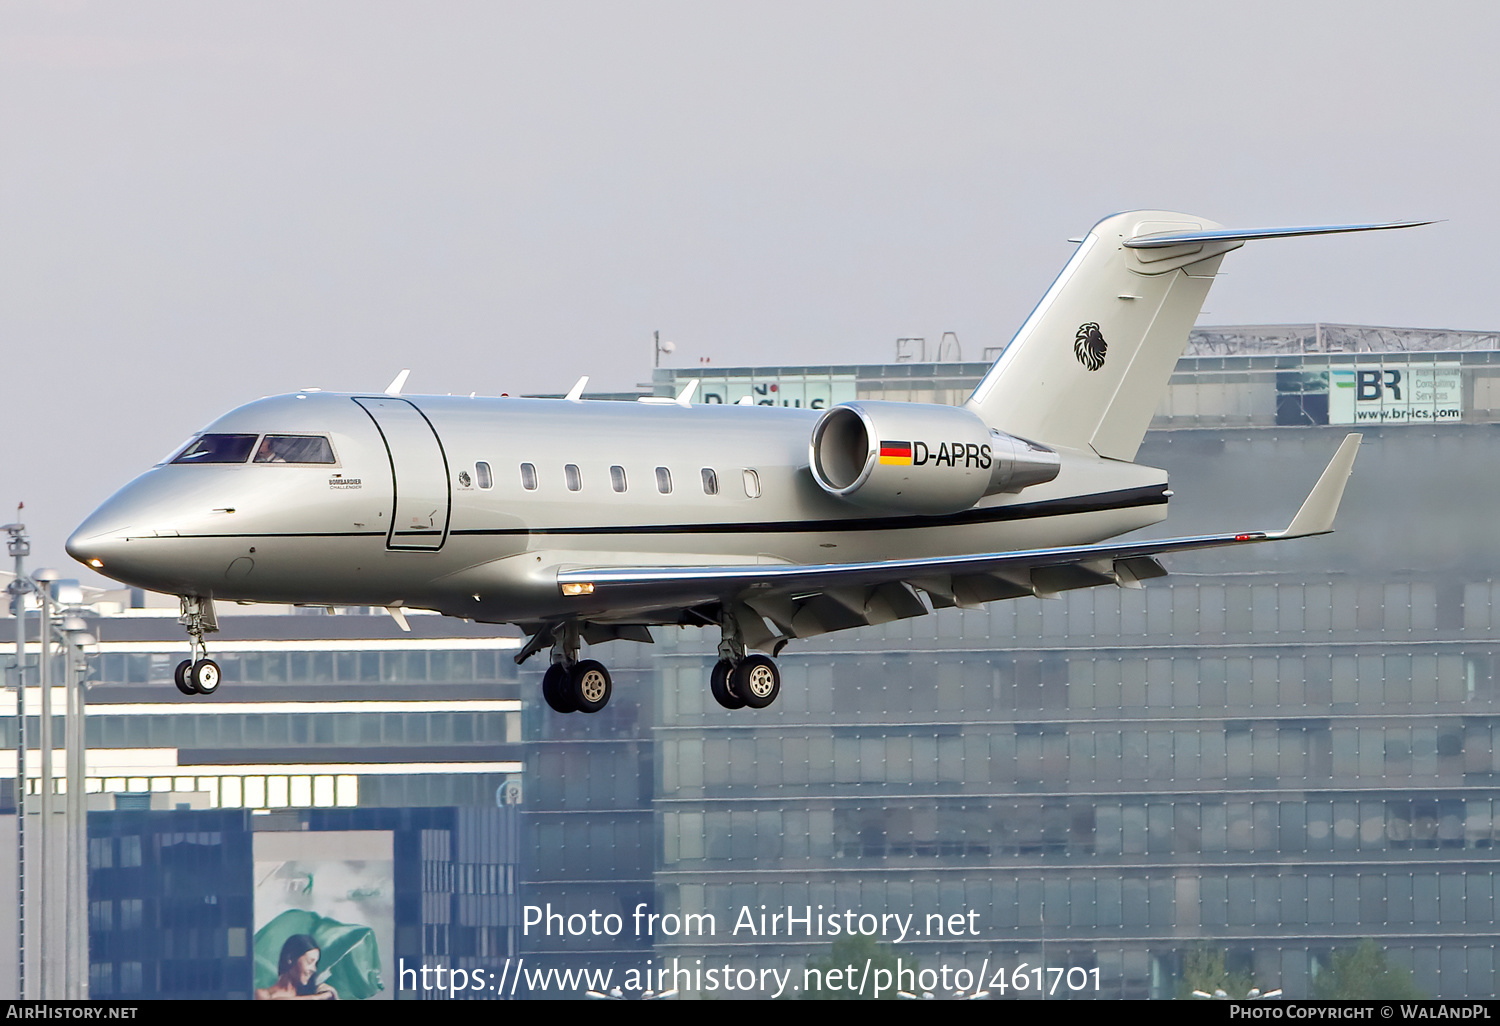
xmin=810 ymin=402 xmax=1059 ymax=513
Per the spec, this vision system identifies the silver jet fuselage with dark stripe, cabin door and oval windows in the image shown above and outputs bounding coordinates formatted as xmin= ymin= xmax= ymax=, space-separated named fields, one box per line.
xmin=68 ymin=392 xmax=1167 ymax=623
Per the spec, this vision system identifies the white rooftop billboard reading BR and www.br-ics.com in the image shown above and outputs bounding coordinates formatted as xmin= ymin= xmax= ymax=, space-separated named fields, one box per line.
xmin=1328 ymin=359 xmax=1464 ymax=425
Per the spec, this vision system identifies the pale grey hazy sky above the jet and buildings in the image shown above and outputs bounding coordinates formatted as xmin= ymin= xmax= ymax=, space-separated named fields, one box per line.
xmin=0 ymin=0 xmax=1500 ymax=572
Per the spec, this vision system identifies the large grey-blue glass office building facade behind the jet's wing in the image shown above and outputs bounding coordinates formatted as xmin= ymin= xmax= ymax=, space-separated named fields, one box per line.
xmin=636 ymin=345 xmax=1500 ymax=998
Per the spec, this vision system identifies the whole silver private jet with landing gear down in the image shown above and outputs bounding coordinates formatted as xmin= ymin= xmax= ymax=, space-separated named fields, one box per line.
xmin=68 ymin=210 xmax=1425 ymax=713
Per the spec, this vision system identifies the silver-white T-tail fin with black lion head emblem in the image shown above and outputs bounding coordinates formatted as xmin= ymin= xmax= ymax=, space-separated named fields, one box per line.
xmin=965 ymin=210 xmax=1431 ymax=461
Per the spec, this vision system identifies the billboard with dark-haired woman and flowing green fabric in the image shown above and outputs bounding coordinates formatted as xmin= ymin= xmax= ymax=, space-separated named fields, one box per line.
xmin=254 ymin=830 xmax=396 ymax=1001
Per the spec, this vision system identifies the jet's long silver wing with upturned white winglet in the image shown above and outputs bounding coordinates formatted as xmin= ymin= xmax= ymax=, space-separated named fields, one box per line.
xmin=557 ymin=434 xmax=1361 ymax=648
